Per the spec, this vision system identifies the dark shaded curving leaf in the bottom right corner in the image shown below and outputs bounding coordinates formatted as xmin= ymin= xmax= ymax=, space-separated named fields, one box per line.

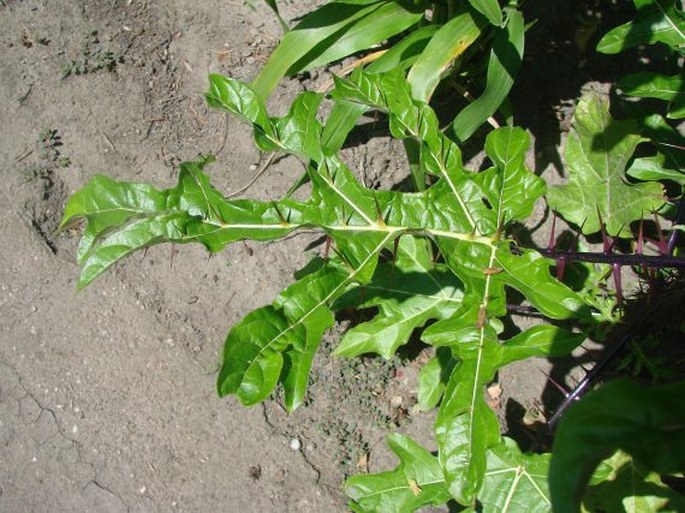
xmin=549 ymin=379 xmax=685 ymax=513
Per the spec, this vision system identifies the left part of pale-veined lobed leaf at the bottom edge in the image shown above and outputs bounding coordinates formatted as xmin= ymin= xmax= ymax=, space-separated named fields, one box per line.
xmin=345 ymin=434 xmax=450 ymax=513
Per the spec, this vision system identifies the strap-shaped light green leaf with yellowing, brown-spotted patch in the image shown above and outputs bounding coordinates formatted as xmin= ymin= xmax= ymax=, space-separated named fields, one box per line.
xmin=407 ymin=6 xmax=482 ymax=102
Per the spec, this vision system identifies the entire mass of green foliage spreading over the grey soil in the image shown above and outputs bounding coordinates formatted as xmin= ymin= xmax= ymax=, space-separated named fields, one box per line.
xmin=62 ymin=0 xmax=685 ymax=512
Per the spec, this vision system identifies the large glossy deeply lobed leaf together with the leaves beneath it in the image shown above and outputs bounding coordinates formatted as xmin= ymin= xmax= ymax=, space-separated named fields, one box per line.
xmin=62 ymin=67 xmax=592 ymax=511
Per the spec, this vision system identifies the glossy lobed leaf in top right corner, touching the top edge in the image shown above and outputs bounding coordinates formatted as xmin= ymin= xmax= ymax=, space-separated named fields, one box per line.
xmin=597 ymin=0 xmax=685 ymax=54
